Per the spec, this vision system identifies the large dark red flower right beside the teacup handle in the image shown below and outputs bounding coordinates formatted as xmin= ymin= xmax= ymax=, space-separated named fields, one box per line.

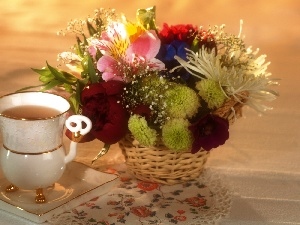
xmin=67 ymin=80 xmax=128 ymax=144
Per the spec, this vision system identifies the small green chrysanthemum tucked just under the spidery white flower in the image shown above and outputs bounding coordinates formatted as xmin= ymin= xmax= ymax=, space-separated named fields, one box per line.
xmin=196 ymin=79 xmax=226 ymax=109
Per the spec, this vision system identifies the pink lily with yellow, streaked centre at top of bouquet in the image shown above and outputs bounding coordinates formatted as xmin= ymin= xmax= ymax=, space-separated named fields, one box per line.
xmin=90 ymin=23 xmax=165 ymax=81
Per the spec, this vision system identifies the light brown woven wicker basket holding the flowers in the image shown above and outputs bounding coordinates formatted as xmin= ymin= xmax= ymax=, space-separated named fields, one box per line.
xmin=119 ymin=135 xmax=209 ymax=185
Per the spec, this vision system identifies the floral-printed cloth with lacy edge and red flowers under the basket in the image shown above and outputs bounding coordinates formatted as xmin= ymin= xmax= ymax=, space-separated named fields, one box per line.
xmin=49 ymin=169 xmax=231 ymax=225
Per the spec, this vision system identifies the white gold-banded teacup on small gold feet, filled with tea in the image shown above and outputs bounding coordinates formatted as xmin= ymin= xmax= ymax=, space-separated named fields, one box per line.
xmin=0 ymin=92 xmax=92 ymax=203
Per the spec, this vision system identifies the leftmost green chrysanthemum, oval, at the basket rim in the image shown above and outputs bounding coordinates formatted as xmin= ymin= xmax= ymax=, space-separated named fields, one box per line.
xmin=128 ymin=115 xmax=157 ymax=146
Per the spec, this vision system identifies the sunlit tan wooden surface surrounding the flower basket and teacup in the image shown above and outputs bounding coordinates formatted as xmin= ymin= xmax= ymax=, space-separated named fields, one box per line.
xmin=0 ymin=0 xmax=300 ymax=225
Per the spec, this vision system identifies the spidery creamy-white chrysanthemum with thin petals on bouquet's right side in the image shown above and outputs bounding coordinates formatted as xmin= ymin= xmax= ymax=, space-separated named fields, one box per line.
xmin=174 ymin=48 xmax=277 ymax=112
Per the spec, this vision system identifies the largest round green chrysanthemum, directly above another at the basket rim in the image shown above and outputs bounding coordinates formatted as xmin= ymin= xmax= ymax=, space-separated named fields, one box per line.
xmin=165 ymin=85 xmax=200 ymax=118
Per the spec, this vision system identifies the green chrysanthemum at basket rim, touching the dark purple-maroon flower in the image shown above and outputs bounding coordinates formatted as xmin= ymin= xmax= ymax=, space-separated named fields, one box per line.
xmin=162 ymin=118 xmax=193 ymax=152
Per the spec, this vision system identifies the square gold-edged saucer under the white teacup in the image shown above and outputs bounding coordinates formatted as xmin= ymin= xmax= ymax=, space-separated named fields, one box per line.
xmin=0 ymin=162 xmax=118 ymax=223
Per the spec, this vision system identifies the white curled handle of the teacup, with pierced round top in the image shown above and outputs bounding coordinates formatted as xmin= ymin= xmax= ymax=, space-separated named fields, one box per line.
xmin=65 ymin=115 xmax=92 ymax=164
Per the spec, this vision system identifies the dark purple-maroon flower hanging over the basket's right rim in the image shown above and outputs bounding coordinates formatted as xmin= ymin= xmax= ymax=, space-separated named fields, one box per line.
xmin=189 ymin=114 xmax=229 ymax=153
